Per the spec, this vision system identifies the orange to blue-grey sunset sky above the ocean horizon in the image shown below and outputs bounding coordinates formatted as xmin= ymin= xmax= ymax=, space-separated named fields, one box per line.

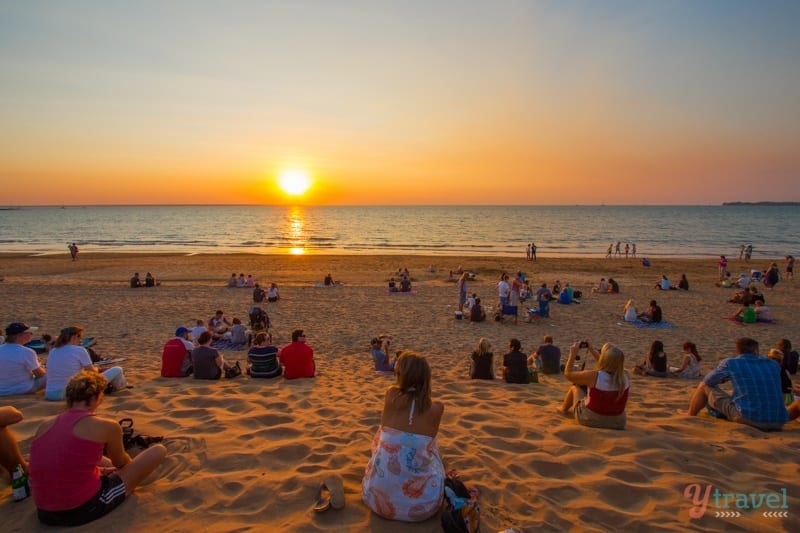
xmin=0 ymin=0 xmax=800 ymax=206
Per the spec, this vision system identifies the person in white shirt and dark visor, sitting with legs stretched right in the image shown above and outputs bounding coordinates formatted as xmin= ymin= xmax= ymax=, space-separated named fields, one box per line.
xmin=44 ymin=326 xmax=128 ymax=401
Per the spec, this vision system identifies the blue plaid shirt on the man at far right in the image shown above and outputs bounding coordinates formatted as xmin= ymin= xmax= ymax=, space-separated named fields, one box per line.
xmin=703 ymin=353 xmax=789 ymax=424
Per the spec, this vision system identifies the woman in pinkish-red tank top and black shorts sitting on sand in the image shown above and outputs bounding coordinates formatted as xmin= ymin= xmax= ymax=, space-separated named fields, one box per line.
xmin=30 ymin=371 xmax=167 ymax=526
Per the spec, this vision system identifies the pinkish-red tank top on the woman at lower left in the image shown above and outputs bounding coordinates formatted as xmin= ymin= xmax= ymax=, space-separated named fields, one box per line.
xmin=30 ymin=410 xmax=103 ymax=511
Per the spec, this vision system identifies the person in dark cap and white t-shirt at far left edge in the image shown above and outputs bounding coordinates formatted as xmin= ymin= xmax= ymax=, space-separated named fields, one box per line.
xmin=0 ymin=322 xmax=47 ymax=396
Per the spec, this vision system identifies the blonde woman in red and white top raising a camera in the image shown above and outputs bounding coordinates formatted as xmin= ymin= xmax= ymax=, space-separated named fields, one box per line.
xmin=558 ymin=341 xmax=630 ymax=429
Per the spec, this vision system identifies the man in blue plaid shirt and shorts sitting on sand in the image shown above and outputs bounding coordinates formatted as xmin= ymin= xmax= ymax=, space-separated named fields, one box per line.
xmin=687 ymin=337 xmax=800 ymax=431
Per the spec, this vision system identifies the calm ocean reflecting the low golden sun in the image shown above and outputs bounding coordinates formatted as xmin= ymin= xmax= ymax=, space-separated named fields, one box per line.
xmin=0 ymin=205 xmax=800 ymax=258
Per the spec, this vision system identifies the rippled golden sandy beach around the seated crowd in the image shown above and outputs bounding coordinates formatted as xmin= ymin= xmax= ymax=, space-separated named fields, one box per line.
xmin=0 ymin=253 xmax=800 ymax=532
